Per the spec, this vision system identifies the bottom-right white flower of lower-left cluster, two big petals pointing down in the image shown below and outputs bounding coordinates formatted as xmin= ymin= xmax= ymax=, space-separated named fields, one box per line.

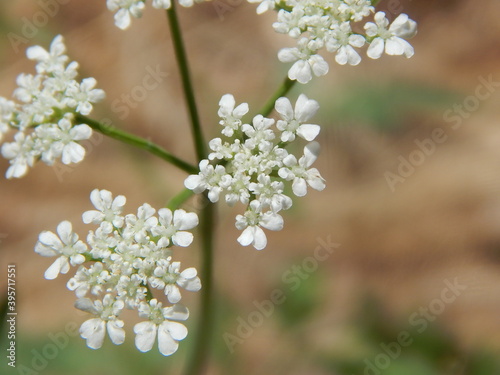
xmin=134 ymin=298 xmax=189 ymax=356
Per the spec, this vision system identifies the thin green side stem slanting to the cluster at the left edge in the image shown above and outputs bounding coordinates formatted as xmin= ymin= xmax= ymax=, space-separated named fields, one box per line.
xmin=75 ymin=113 xmax=198 ymax=174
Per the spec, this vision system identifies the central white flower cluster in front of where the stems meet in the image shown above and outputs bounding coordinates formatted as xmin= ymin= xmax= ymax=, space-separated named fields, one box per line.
xmin=184 ymin=94 xmax=325 ymax=250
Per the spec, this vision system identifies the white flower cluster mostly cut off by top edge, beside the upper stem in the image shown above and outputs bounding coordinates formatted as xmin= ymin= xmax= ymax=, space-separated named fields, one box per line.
xmin=106 ymin=0 xmax=204 ymax=30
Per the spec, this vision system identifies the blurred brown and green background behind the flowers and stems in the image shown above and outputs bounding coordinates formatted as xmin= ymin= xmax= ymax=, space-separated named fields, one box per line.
xmin=0 ymin=0 xmax=500 ymax=375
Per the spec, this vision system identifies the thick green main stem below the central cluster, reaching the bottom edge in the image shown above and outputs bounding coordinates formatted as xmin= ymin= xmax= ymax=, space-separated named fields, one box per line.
xmin=184 ymin=198 xmax=215 ymax=375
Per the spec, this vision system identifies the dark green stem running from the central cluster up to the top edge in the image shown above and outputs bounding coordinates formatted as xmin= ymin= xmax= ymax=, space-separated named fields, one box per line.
xmin=167 ymin=1 xmax=207 ymax=161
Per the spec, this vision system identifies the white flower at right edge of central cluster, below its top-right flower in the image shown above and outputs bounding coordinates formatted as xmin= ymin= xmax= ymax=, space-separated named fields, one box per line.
xmin=278 ymin=142 xmax=326 ymax=197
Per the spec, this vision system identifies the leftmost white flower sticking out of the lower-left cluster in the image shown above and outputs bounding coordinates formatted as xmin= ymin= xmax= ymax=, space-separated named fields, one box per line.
xmin=35 ymin=221 xmax=87 ymax=280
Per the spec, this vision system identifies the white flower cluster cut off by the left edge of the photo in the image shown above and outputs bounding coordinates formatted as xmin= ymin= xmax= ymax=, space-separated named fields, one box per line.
xmin=0 ymin=35 xmax=105 ymax=178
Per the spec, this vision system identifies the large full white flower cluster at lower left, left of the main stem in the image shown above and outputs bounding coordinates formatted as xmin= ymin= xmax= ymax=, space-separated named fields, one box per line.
xmin=35 ymin=189 xmax=201 ymax=355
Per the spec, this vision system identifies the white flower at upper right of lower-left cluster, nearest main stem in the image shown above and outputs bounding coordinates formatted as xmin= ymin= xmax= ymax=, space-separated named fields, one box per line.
xmin=151 ymin=208 xmax=198 ymax=247
